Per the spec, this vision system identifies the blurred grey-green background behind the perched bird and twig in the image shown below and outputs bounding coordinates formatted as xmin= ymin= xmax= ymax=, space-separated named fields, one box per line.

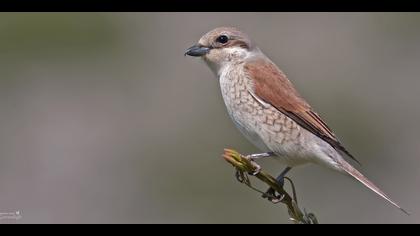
xmin=0 ymin=13 xmax=420 ymax=223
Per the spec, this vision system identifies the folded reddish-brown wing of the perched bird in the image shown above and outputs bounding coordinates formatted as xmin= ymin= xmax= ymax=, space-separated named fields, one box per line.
xmin=244 ymin=59 xmax=359 ymax=163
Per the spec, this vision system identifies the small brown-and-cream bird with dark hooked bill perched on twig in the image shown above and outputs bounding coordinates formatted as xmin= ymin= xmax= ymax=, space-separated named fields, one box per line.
xmin=184 ymin=27 xmax=409 ymax=214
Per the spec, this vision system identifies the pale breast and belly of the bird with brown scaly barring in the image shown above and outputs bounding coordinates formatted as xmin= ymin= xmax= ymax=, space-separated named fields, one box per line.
xmin=219 ymin=65 xmax=303 ymax=163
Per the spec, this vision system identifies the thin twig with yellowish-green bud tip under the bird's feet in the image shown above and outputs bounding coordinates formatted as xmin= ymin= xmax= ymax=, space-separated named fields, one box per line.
xmin=223 ymin=149 xmax=318 ymax=224
